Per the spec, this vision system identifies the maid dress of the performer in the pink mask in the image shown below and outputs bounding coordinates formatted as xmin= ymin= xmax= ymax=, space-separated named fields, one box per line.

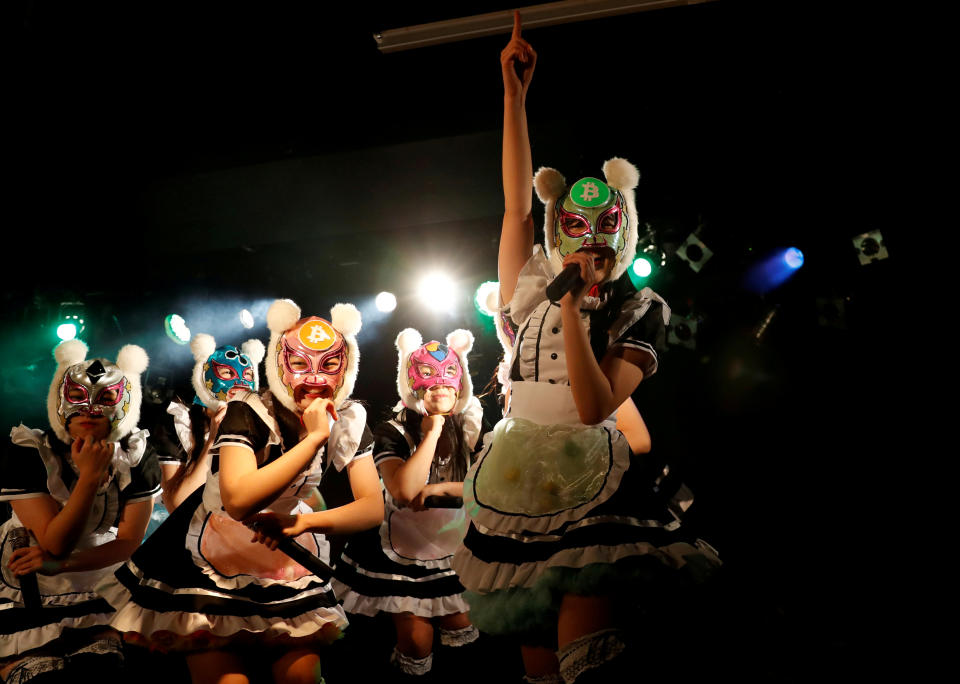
xmin=334 ymin=397 xmax=483 ymax=618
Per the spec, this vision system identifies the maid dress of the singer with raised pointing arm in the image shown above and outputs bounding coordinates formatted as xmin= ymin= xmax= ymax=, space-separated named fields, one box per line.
xmin=452 ymin=250 xmax=719 ymax=644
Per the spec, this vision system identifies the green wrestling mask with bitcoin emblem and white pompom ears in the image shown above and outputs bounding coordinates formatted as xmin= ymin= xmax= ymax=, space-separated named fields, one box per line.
xmin=533 ymin=157 xmax=640 ymax=280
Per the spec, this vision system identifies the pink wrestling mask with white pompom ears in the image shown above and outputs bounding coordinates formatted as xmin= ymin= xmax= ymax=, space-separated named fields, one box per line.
xmin=397 ymin=328 xmax=473 ymax=414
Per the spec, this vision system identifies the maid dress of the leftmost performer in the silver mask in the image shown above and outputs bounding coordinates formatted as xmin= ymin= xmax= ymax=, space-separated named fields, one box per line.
xmin=0 ymin=425 xmax=160 ymax=659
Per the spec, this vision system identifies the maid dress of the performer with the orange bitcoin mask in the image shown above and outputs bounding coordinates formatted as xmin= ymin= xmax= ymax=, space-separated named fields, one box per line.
xmin=98 ymin=392 xmax=373 ymax=651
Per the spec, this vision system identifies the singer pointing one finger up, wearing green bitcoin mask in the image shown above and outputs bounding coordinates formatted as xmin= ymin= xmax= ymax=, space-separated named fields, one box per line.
xmin=453 ymin=15 xmax=716 ymax=684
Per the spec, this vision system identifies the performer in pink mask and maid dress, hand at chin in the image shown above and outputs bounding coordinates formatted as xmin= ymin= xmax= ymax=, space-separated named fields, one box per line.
xmin=334 ymin=328 xmax=483 ymax=675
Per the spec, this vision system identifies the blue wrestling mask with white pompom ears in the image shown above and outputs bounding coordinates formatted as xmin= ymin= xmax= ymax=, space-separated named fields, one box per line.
xmin=190 ymin=333 xmax=264 ymax=410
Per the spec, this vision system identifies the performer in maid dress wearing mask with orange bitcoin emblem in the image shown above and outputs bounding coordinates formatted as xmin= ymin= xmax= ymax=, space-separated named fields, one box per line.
xmin=99 ymin=300 xmax=383 ymax=682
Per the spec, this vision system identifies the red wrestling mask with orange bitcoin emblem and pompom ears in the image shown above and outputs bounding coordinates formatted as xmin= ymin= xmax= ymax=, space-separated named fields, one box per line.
xmin=266 ymin=299 xmax=361 ymax=413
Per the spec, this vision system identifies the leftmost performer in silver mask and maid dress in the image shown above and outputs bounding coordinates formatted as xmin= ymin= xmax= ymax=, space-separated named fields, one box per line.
xmin=0 ymin=340 xmax=160 ymax=684
